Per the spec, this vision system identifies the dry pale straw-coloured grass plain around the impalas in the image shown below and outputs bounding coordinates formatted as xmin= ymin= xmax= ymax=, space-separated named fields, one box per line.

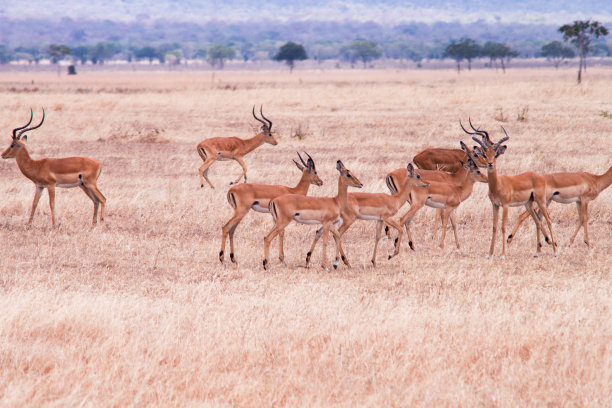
xmin=0 ymin=68 xmax=612 ymax=407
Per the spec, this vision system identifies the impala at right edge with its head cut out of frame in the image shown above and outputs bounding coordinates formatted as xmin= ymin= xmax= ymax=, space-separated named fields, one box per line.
xmin=507 ymin=166 xmax=612 ymax=248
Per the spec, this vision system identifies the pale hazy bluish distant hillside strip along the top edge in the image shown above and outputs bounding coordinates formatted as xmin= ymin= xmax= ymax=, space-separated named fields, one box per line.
xmin=0 ymin=0 xmax=612 ymax=24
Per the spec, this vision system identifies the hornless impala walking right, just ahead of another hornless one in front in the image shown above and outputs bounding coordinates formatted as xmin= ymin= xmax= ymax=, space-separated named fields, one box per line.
xmin=306 ymin=163 xmax=429 ymax=268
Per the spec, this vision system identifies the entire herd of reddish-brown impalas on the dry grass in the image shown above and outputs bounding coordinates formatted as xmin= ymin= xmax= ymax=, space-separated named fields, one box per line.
xmin=2 ymin=107 xmax=612 ymax=269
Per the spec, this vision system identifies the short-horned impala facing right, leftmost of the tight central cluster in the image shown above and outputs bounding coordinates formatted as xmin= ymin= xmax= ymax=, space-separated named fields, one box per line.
xmin=219 ymin=153 xmax=323 ymax=263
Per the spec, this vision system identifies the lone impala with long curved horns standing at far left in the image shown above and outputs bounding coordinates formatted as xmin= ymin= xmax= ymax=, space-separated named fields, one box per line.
xmin=2 ymin=109 xmax=106 ymax=227
